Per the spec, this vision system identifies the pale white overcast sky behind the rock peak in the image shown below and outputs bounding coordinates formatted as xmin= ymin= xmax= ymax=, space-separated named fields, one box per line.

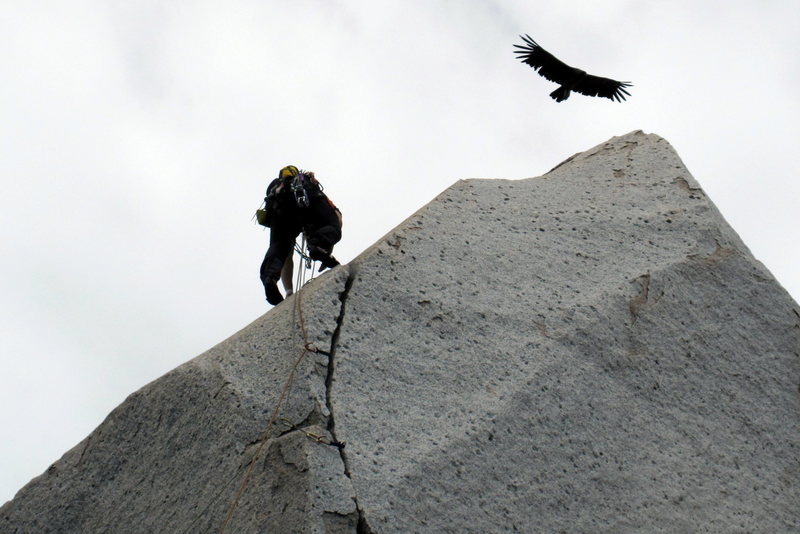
xmin=0 ymin=0 xmax=800 ymax=504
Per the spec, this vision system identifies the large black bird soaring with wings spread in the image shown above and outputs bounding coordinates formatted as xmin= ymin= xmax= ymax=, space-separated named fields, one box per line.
xmin=514 ymin=34 xmax=631 ymax=102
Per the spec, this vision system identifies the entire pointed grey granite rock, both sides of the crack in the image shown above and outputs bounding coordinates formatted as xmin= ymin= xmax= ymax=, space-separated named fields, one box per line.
xmin=0 ymin=132 xmax=800 ymax=534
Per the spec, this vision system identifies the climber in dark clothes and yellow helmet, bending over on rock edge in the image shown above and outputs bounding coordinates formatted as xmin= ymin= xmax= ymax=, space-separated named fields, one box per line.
xmin=260 ymin=165 xmax=342 ymax=305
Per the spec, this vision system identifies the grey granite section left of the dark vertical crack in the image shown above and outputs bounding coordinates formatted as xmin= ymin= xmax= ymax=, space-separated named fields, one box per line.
xmin=0 ymin=269 xmax=358 ymax=534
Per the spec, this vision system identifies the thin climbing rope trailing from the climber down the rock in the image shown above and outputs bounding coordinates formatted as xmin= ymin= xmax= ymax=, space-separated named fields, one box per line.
xmin=220 ymin=240 xmax=317 ymax=534
